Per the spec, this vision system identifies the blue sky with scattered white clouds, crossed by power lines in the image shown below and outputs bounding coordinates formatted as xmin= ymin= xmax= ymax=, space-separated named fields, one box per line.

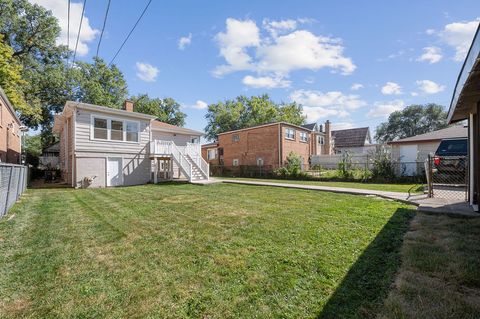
xmin=31 ymin=0 xmax=480 ymax=139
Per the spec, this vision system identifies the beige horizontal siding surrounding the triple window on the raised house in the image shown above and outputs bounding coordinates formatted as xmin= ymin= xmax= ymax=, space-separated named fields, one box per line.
xmin=76 ymin=110 xmax=150 ymax=154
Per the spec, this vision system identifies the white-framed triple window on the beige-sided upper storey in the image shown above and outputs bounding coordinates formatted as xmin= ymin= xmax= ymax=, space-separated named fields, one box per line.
xmin=92 ymin=117 xmax=140 ymax=142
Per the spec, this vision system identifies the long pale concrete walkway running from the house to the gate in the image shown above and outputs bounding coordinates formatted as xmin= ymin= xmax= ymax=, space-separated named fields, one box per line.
xmin=219 ymin=178 xmax=480 ymax=217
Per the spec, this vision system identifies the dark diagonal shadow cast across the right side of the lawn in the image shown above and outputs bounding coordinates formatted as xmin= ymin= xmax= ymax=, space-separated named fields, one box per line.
xmin=317 ymin=208 xmax=415 ymax=319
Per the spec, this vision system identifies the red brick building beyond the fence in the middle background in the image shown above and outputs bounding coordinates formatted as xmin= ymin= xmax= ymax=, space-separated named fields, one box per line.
xmin=202 ymin=121 xmax=331 ymax=169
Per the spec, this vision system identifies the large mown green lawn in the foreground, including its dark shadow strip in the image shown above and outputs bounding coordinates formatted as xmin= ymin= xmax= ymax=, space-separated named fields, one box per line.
xmin=0 ymin=184 xmax=414 ymax=318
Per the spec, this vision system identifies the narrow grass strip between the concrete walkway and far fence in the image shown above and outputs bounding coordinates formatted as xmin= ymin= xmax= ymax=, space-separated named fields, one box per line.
xmin=219 ymin=177 xmax=423 ymax=194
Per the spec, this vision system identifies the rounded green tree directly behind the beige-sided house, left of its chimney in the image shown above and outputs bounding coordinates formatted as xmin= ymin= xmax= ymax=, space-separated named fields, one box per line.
xmin=72 ymin=57 xmax=128 ymax=108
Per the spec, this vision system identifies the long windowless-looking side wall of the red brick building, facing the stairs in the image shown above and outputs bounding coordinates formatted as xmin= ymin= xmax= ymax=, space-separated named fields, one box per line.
xmin=218 ymin=124 xmax=279 ymax=167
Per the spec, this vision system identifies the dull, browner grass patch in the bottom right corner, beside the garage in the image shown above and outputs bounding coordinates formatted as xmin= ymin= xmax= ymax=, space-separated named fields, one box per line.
xmin=380 ymin=213 xmax=480 ymax=319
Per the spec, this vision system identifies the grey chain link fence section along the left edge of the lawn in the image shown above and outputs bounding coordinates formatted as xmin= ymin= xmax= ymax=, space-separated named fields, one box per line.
xmin=0 ymin=163 xmax=28 ymax=218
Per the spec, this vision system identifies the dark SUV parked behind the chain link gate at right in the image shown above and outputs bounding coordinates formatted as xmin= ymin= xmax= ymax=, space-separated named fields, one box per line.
xmin=433 ymin=138 xmax=468 ymax=173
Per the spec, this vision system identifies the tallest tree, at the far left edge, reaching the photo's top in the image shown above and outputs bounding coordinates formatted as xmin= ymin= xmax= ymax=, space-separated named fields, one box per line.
xmin=0 ymin=0 xmax=70 ymax=128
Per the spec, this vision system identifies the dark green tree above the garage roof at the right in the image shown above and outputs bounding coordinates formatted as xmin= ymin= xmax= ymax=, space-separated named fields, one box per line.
xmin=375 ymin=103 xmax=448 ymax=143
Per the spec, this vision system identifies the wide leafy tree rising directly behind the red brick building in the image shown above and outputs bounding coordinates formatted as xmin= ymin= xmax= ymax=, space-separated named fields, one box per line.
xmin=205 ymin=94 xmax=305 ymax=140
